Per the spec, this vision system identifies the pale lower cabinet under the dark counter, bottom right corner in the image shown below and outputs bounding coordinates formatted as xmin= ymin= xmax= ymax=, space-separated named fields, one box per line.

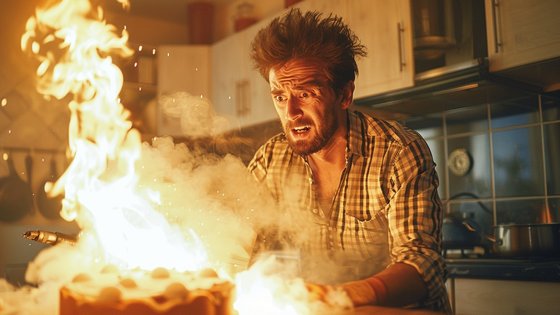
xmin=447 ymin=278 xmax=560 ymax=315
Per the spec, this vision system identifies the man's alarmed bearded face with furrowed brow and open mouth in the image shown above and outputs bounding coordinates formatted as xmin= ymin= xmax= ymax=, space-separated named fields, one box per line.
xmin=269 ymin=59 xmax=344 ymax=155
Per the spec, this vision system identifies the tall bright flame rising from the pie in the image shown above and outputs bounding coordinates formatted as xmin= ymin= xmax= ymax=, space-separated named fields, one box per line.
xmin=22 ymin=0 xmax=207 ymax=270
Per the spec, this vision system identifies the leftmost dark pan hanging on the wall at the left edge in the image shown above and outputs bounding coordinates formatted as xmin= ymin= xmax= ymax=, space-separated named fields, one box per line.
xmin=0 ymin=155 xmax=33 ymax=222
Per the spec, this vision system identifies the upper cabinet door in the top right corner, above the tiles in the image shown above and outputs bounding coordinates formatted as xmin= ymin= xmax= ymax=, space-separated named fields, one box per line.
xmin=485 ymin=0 xmax=560 ymax=71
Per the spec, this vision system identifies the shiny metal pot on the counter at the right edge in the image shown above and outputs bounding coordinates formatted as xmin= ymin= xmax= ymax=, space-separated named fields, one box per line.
xmin=493 ymin=223 xmax=560 ymax=257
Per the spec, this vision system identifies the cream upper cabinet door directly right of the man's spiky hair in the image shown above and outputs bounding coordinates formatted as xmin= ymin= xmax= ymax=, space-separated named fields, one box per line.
xmin=347 ymin=0 xmax=414 ymax=98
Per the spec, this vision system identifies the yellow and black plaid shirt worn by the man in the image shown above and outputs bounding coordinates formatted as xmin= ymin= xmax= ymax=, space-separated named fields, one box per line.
xmin=248 ymin=111 xmax=450 ymax=312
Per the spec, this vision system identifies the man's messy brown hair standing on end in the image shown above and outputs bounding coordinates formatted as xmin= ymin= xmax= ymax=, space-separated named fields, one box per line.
xmin=251 ymin=8 xmax=367 ymax=91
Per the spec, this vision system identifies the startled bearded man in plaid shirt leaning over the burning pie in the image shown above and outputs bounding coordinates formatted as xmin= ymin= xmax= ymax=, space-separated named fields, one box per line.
xmin=248 ymin=9 xmax=450 ymax=312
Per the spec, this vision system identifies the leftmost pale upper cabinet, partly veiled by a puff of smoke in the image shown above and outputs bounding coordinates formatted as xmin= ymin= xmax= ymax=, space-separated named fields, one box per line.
xmin=156 ymin=45 xmax=211 ymax=137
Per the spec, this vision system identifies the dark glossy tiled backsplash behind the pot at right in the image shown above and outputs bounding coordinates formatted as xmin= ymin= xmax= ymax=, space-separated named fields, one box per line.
xmin=404 ymin=95 xmax=560 ymax=230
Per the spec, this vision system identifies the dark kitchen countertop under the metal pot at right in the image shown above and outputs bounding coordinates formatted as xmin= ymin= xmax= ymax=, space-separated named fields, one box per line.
xmin=446 ymin=257 xmax=560 ymax=282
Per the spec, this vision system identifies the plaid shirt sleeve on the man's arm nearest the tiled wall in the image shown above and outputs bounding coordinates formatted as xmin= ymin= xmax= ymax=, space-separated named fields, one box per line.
xmin=388 ymin=139 xmax=447 ymax=304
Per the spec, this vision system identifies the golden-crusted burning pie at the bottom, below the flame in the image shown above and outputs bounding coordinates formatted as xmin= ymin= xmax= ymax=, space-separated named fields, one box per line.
xmin=59 ymin=266 xmax=233 ymax=315
